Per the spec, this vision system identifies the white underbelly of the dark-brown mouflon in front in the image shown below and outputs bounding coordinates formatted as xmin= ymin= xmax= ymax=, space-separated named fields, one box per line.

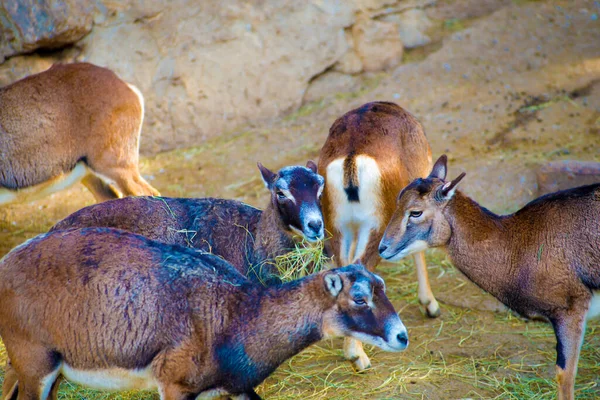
xmin=61 ymin=364 xmax=158 ymax=390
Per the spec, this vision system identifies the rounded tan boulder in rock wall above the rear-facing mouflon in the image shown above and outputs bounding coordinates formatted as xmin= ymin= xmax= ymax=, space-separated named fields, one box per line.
xmin=352 ymin=14 xmax=404 ymax=72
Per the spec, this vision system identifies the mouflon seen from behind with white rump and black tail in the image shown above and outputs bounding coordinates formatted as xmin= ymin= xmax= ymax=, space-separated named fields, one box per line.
xmin=319 ymin=102 xmax=440 ymax=370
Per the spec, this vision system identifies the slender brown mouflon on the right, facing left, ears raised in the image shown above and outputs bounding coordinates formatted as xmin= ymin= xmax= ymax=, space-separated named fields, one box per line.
xmin=379 ymin=156 xmax=600 ymax=399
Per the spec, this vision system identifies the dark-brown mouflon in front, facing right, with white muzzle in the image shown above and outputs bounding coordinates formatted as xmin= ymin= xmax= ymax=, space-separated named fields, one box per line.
xmin=0 ymin=228 xmax=408 ymax=400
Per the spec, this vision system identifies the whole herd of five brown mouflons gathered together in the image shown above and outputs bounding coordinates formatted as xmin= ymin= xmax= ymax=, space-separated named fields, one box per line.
xmin=0 ymin=63 xmax=600 ymax=400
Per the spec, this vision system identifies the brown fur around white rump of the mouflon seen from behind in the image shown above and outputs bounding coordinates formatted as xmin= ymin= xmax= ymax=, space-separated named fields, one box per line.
xmin=318 ymin=102 xmax=439 ymax=370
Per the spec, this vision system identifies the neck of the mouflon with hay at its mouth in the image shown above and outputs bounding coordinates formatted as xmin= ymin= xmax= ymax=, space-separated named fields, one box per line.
xmin=254 ymin=202 xmax=295 ymax=263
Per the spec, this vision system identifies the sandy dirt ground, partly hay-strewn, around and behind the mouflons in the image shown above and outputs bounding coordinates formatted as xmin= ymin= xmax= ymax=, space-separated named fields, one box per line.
xmin=0 ymin=0 xmax=600 ymax=399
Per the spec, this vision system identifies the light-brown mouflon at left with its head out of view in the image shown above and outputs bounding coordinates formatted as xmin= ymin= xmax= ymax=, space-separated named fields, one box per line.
xmin=0 ymin=63 xmax=158 ymax=204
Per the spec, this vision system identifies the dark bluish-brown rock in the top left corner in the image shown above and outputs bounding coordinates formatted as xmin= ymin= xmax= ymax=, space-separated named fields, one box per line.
xmin=0 ymin=0 xmax=101 ymax=62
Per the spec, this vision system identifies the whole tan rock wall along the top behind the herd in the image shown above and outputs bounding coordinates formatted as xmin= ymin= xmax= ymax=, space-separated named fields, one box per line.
xmin=0 ymin=0 xmax=431 ymax=155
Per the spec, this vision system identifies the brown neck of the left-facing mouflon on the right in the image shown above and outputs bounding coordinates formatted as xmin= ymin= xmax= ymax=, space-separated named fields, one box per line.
xmin=444 ymin=192 xmax=511 ymax=301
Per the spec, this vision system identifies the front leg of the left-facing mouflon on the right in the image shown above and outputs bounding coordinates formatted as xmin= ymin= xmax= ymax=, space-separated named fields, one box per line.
xmin=552 ymin=308 xmax=585 ymax=400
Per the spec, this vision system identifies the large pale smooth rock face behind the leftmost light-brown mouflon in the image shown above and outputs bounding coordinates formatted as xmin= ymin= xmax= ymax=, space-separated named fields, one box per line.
xmin=77 ymin=0 xmax=354 ymax=154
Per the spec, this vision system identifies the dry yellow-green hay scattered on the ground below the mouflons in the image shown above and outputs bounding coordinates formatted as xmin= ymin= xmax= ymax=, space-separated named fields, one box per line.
xmin=0 ymin=251 xmax=600 ymax=400
